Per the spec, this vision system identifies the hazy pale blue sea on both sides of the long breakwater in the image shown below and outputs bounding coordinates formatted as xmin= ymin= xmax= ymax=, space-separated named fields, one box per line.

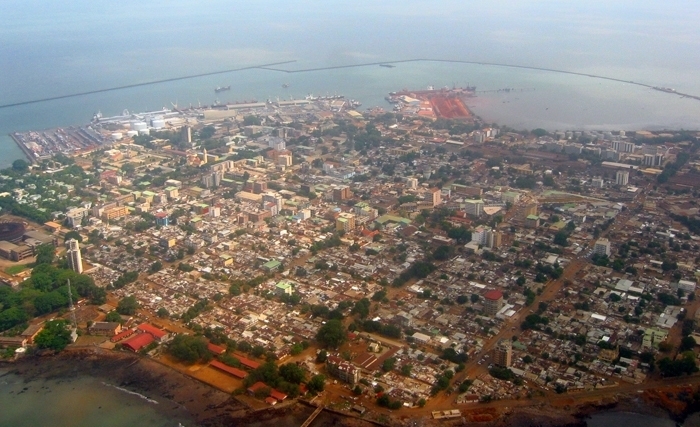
xmin=0 ymin=0 xmax=700 ymax=167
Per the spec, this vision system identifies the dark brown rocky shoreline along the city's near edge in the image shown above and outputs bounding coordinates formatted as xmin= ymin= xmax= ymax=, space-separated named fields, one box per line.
xmin=0 ymin=349 xmax=687 ymax=427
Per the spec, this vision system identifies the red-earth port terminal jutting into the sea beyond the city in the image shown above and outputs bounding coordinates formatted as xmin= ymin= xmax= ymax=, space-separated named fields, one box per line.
xmin=386 ymin=87 xmax=475 ymax=121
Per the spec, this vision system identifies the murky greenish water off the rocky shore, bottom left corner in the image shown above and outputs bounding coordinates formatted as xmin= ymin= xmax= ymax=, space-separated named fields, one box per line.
xmin=0 ymin=372 xmax=191 ymax=427
